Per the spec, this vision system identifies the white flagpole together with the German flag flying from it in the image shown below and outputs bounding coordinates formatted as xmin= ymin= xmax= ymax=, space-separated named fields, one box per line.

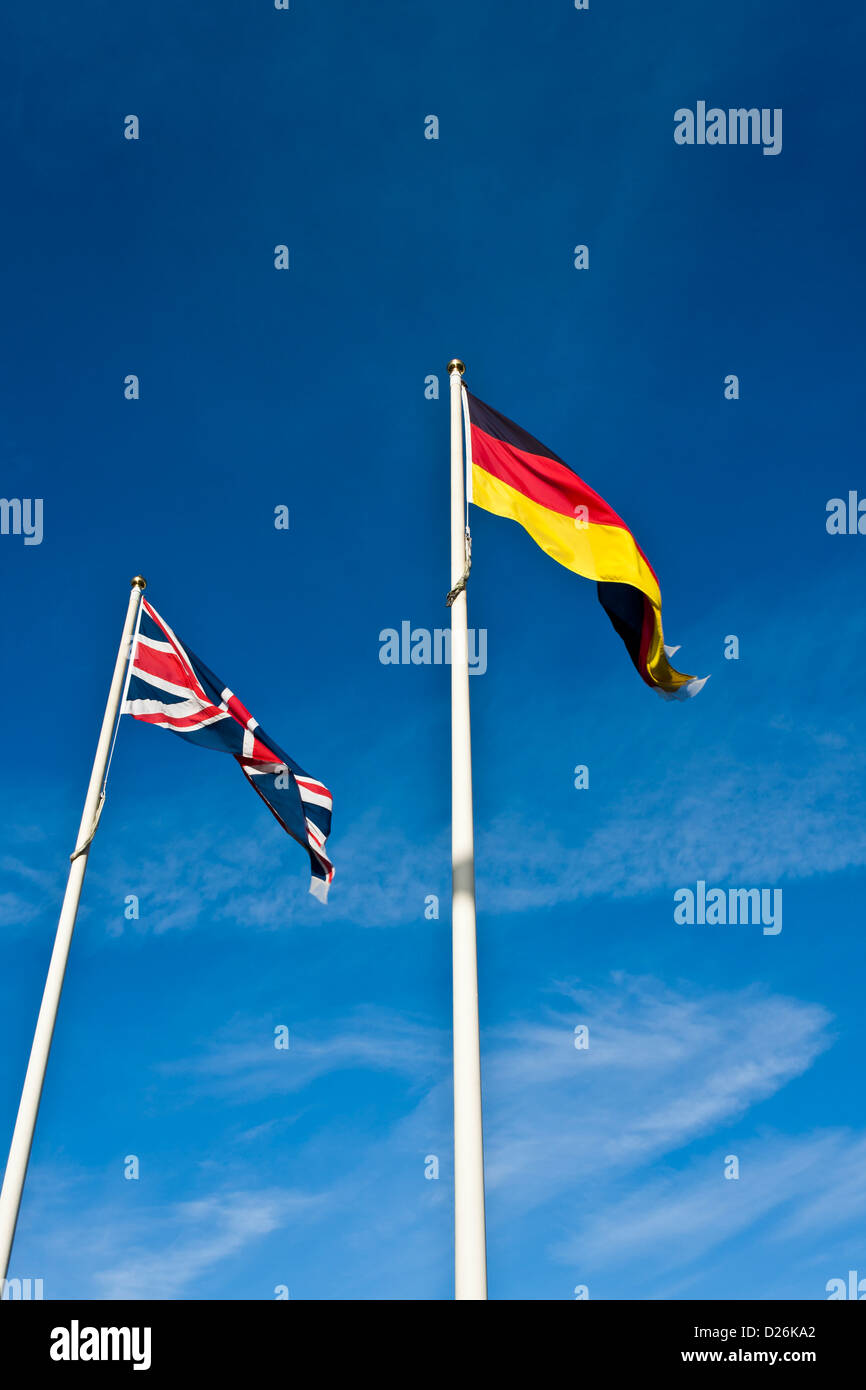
xmin=448 ymin=359 xmax=709 ymax=1298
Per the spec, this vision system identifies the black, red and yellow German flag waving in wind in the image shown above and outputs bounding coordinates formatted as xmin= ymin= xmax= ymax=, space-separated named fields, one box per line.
xmin=463 ymin=386 xmax=709 ymax=699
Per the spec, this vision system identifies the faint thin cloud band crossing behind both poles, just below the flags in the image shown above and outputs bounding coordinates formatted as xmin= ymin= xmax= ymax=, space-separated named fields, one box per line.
xmin=25 ymin=728 xmax=866 ymax=934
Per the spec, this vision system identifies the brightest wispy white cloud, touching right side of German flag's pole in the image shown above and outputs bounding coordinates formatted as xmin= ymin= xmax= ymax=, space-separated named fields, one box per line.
xmin=485 ymin=979 xmax=830 ymax=1205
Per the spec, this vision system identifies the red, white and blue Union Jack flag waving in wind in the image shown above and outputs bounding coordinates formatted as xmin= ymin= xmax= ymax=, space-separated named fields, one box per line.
xmin=121 ymin=599 xmax=334 ymax=902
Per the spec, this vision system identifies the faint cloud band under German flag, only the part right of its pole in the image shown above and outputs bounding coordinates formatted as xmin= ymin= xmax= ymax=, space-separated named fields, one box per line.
xmin=477 ymin=756 xmax=866 ymax=913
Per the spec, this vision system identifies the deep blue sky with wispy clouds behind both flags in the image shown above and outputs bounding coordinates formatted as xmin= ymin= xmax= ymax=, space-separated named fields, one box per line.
xmin=0 ymin=0 xmax=866 ymax=1300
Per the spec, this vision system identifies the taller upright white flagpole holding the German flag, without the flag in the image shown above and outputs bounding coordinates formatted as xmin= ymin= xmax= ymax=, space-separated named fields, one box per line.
xmin=448 ymin=359 xmax=487 ymax=1300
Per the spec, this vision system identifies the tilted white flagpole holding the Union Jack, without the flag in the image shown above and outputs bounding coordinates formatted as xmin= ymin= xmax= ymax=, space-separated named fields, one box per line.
xmin=0 ymin=574 xmax=145 ymax=1280
